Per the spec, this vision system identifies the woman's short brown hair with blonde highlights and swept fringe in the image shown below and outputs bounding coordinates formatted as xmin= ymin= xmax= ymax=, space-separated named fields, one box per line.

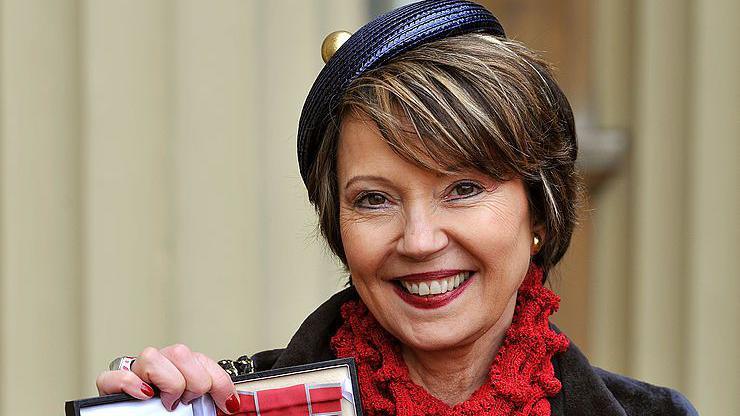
xmin=306 ymin=34 xmax=581 ymax=277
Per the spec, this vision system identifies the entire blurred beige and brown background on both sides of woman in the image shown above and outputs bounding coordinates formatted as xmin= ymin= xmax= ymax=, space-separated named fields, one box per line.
xmin=0 ymin=0 xmax=740 ymax=415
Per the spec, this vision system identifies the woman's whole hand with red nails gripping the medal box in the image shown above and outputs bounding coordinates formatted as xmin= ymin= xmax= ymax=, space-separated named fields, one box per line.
xmin=95 ymin=344 xmax=239 ymax=413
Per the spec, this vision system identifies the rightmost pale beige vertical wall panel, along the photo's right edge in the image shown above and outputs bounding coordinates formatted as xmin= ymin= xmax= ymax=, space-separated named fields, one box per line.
xmin=687 ymin=0 xmax=740 ymax=415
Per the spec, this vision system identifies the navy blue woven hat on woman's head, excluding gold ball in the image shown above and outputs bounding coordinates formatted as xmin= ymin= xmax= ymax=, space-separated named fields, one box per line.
xmin=298 ymin=0 xmax=506 ymax=183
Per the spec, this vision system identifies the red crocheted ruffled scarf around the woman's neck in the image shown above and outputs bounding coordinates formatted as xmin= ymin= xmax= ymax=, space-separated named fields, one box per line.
xmin=331 ymin=265 xmax=568 ymax=416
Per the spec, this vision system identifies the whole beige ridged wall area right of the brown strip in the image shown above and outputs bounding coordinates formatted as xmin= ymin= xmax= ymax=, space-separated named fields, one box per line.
xmin=589 ymin=0 xmax=740 ymax=415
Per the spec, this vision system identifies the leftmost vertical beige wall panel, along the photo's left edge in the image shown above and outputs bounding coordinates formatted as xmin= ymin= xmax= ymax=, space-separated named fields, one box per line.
xmin=0 ymin=0 xmax=81 ymax=415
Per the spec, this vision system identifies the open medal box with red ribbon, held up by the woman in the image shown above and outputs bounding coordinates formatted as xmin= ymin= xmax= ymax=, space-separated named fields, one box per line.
xmin=65 ymin=358 xmax=362 ymax=416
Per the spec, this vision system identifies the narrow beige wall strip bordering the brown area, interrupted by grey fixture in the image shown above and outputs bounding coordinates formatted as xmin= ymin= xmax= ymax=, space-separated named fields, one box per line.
xmin=589 ymin=0 xmax=633 ymax=372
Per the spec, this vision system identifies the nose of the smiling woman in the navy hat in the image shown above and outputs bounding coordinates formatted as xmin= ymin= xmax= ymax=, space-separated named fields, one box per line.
xmin=397 ymin=210 xmax=449 ymax=260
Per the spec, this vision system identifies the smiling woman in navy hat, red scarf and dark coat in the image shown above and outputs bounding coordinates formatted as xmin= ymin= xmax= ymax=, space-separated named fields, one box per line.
xmin=97 ymin=0 xmax=696 ymax=415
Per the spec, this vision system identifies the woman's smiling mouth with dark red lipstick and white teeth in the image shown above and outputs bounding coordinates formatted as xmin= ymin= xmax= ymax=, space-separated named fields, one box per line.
xmin=395 ymin=271 xmax=475 ymax=309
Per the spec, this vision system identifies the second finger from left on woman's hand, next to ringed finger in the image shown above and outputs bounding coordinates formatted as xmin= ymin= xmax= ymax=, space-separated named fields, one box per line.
xmin=131 ymin=347 xmax=187 ymax=410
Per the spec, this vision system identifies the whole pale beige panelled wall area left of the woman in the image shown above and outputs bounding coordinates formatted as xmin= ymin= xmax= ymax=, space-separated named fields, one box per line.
xmin=0 ymin=0 xmax=367 ymax=415
